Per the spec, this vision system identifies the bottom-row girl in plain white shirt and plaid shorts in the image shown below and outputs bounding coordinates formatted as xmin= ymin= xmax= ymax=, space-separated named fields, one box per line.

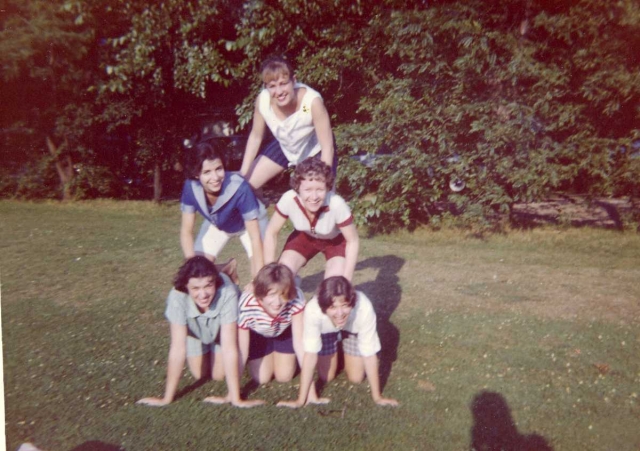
xmin=278 ymin=276 xmax=398 ymax=408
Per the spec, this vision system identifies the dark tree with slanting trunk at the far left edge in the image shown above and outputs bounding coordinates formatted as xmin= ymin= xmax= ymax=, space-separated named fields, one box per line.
xmin=0 ymin=0 xmax=101 ymax=200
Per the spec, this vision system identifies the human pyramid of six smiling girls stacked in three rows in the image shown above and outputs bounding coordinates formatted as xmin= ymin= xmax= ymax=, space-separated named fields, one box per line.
xmin=138 ymin=57 xmax=398 ymax=408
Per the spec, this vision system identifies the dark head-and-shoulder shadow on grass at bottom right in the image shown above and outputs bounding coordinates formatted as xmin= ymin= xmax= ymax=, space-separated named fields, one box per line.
xmin=469 ymin=391 xmax=553 ymax=451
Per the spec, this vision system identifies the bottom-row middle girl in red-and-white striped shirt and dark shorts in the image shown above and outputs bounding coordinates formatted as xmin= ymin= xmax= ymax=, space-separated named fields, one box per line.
xmin=238 ymin=263 xmax=320 ymax=403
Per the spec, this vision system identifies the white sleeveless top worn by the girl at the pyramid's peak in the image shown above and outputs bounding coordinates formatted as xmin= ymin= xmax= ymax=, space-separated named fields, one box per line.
xmin=258 ymin=83 xmax=322 ymax=165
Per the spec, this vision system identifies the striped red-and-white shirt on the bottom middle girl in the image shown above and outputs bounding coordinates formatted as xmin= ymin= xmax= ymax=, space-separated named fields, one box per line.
xmin=238 ymin=288 xmax=305 ymax=337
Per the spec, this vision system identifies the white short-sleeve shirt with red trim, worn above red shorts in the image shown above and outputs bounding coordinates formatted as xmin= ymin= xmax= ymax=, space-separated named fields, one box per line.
xmin=276 ymin=190 xmax=353 ymax=240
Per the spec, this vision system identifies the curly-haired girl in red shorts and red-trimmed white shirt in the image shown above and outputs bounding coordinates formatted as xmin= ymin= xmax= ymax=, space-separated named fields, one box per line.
xmin=264 ymin=158 xmax=359 ymax=280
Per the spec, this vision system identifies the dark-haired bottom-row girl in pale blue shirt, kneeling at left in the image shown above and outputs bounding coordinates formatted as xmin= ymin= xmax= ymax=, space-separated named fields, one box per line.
xmin=137 ymin=256 xmax=264 ymax=407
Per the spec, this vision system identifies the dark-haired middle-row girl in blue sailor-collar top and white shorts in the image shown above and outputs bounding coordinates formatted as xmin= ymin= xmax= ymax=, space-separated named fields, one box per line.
xmin=180 ymin=141 xmax=266 ymax=282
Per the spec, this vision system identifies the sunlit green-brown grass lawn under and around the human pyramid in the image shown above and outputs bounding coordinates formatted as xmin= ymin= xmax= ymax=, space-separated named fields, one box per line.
xmin=0 ymin=201 xmax=640 ymax=451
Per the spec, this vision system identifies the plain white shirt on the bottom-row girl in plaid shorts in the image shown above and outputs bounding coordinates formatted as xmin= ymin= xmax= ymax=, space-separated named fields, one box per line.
xmin=302 ymin=291 xmax=381 ymax=357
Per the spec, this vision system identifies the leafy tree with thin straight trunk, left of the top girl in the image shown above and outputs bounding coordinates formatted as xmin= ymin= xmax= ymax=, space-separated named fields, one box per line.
xmin=102 ymin=0 xmax=249 ymax=200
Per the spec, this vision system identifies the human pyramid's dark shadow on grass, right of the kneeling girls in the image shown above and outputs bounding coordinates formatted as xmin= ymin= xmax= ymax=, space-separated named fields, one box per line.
xmin=301 ymin=255 xmax=404 ymax=389
